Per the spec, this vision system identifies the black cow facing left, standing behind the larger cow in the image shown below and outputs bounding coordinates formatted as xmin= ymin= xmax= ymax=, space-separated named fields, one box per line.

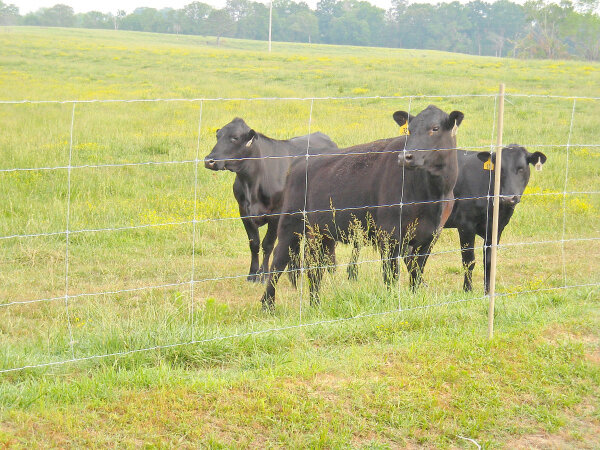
xmin=204 ymin=118 xmax=338 ymax=281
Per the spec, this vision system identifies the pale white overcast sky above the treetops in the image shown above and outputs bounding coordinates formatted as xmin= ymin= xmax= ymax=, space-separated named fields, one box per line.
xmin=11 ymin=0 xmax=398 ymax=15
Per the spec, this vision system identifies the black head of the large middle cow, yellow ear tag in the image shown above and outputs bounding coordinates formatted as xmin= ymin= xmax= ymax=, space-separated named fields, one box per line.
xmin=394 ymin=105 xmax=464 ymax=174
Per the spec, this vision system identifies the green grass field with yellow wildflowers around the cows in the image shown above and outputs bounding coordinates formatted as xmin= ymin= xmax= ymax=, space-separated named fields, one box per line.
xmin=0 ymin=28 xmax=600 ymax=448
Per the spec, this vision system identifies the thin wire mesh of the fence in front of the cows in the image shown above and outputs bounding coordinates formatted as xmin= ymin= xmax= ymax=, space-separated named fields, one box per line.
xmin=0 ymin=93 xmax=600 ymax=373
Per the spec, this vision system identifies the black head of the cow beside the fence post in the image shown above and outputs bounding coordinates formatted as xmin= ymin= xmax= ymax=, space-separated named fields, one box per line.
xmin=477 ymin=144 xmax=546 ymax=208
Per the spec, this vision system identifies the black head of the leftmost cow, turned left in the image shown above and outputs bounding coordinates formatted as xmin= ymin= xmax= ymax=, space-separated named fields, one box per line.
xmin=204 ymin=117 xmax=257 ymax=172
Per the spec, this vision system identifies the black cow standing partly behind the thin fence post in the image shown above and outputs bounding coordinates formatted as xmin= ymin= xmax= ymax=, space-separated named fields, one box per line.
xmin=444 ymin=144 xmax=546 ymax=294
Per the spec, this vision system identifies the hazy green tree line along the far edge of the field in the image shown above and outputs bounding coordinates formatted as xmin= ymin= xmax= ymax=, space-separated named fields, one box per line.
xmin=0 ymin=0 xmax=600 ymax=61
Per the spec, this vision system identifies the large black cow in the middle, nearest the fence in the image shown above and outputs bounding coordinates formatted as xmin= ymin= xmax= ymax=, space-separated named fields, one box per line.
xmin=262 ymin=105 xmax=464 ymax=309
